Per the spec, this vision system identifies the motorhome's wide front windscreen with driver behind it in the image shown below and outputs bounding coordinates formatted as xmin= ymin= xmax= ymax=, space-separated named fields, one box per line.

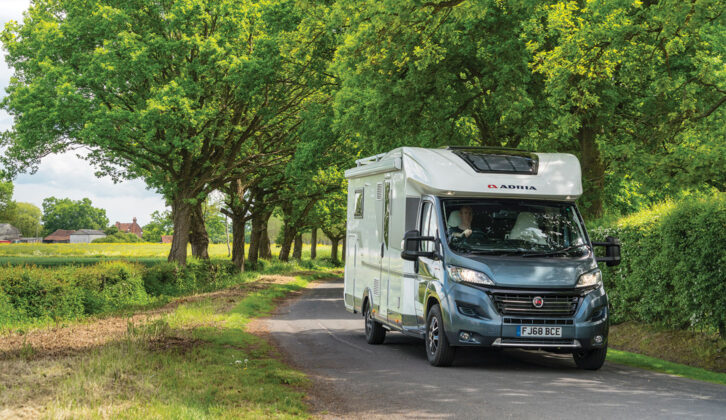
xmin=442 ymin=199 xmax=589 ymax=257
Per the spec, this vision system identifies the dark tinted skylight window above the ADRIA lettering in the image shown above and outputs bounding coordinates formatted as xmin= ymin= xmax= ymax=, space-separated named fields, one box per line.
xmin=447 ymin=147 xmax=539 ymax=175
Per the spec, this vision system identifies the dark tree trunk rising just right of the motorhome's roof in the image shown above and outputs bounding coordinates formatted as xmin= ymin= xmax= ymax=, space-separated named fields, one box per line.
xmin=579 ymin=121 xmax=605 ymax=218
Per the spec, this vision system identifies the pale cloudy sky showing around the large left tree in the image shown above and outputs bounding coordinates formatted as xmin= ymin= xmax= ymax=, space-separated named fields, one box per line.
xmin=0 ymin=0 xmax=166 ymax=226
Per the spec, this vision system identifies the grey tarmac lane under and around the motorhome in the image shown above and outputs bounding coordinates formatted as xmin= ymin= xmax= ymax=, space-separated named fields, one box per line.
xmin=267 ymin=280 xmax=726 ymax=419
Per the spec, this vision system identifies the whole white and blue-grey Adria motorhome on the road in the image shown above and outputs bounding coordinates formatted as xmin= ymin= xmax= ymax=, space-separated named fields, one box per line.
xmin=344 ymin=147 xmax=620 ymax=369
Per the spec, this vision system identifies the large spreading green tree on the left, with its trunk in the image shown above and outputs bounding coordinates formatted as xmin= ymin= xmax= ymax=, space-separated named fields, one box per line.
xmin=2 ymin=0 xmax=330 ymax=263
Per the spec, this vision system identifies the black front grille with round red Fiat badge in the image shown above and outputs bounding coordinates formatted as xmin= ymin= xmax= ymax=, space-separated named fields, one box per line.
xmin=490 ymin=292 xmax=580 ymax=317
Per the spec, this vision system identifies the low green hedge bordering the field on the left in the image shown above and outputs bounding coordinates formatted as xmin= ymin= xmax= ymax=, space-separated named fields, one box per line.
xmin=0 ymin=260 xmax=240 ymax=329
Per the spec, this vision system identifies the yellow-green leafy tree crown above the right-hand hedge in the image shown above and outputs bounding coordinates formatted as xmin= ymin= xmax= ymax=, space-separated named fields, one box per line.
xmin=525 ymin=0 xmax=726 ymax=215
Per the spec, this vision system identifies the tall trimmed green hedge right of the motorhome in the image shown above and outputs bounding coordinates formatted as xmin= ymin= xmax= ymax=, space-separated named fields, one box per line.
xmin=590 ymin=193 xmax=726 ymax=336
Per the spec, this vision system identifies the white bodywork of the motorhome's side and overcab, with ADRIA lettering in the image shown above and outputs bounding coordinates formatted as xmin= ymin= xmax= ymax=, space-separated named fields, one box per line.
xmin=344 ymin=147 xmax=582 ymax=333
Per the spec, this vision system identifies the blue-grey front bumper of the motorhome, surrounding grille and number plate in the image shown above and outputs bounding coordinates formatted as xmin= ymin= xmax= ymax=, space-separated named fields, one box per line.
xmin=444 ymin=283 xmax=609 ymax=351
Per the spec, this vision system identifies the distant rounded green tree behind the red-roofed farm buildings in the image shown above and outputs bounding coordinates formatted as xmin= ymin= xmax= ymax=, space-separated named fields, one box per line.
xmin=43 ymin=197 xmax=108 ymax=235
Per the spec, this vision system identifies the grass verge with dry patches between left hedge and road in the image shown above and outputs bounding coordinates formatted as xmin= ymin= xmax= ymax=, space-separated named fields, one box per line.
xmin=0 ymin=272 xmax=330 ymax=419
